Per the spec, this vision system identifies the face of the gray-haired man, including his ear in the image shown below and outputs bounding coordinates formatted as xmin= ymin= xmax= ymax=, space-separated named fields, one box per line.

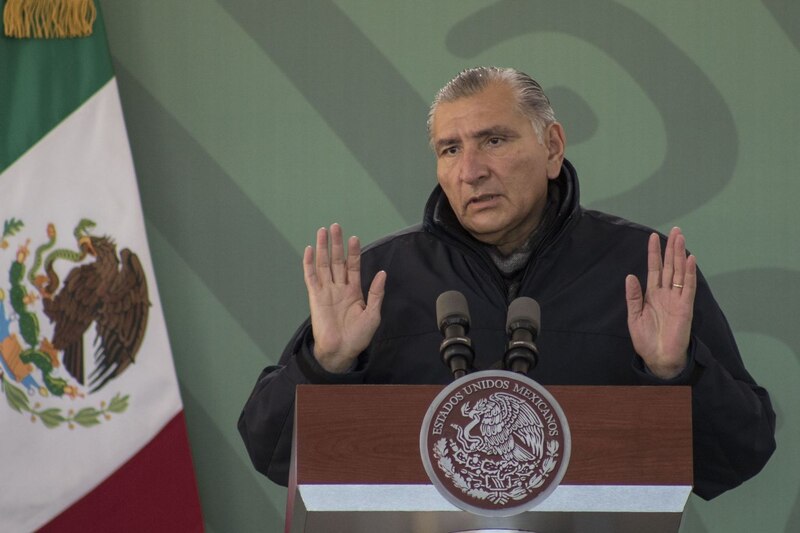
xmin=431 ymin=83 xmax=564 ymax=254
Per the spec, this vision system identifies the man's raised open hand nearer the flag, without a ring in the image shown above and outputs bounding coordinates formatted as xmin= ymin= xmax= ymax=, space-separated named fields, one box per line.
xmin=303 ymin=224 xmax=386 ymax=373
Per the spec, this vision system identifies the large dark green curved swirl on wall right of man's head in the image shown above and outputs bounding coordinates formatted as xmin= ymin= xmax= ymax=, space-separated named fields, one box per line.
xmin=447 ymin=0 xmax=738 ymax=225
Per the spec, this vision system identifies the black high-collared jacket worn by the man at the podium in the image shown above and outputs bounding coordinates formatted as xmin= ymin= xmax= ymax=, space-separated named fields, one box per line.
xmin=239 ymin=161 xmax=775 ymax=499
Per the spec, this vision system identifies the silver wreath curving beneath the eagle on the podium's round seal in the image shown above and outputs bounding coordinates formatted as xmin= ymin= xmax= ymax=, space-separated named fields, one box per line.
xmin=433 ymin=438 xmax=559 ymax=505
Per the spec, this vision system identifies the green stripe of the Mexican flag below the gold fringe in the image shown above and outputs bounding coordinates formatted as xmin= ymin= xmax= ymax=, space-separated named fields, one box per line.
xmin=0 ymin=6 xmax=114 ymax=173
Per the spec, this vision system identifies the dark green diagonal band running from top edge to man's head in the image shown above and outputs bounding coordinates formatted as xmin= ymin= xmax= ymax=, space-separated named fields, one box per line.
xmin=219 ymin=0 xmax=431 ymax=224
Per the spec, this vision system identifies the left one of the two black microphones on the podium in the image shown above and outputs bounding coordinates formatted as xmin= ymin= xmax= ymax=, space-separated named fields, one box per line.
xmin=436 ymin=291 xmax=475 ymax=379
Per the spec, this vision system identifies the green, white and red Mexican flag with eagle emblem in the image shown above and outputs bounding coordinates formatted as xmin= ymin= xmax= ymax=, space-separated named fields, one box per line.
xmin=0 ymin=4 xmax=203 ymax=532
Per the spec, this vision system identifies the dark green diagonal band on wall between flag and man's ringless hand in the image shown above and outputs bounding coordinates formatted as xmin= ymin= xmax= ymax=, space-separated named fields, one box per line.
xmin=114 ymin=61 xmax=304 ymax=353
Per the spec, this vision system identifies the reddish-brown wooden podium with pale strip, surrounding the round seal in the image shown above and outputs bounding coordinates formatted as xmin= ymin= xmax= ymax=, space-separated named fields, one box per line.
xmin=285 ymin=385 xmax=692 ymax=533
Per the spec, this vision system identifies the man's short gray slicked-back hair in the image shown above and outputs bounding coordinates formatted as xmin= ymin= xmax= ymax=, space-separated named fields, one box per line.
xmin=428 ymin=67 xmax=556 ymax=142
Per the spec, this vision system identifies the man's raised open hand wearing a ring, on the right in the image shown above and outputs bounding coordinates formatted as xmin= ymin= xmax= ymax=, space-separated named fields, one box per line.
xmin=625 ymin=228 xmax=697 ymax=379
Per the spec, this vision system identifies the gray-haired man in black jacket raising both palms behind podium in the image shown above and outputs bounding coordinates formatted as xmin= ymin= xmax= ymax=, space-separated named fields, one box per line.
xmin=239 ymin=67 xmax=775 ymax=499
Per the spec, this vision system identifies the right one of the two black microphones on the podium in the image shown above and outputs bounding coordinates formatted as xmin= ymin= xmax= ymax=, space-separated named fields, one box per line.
xmin=503 ymin=296 xmax=541 ymax=374
